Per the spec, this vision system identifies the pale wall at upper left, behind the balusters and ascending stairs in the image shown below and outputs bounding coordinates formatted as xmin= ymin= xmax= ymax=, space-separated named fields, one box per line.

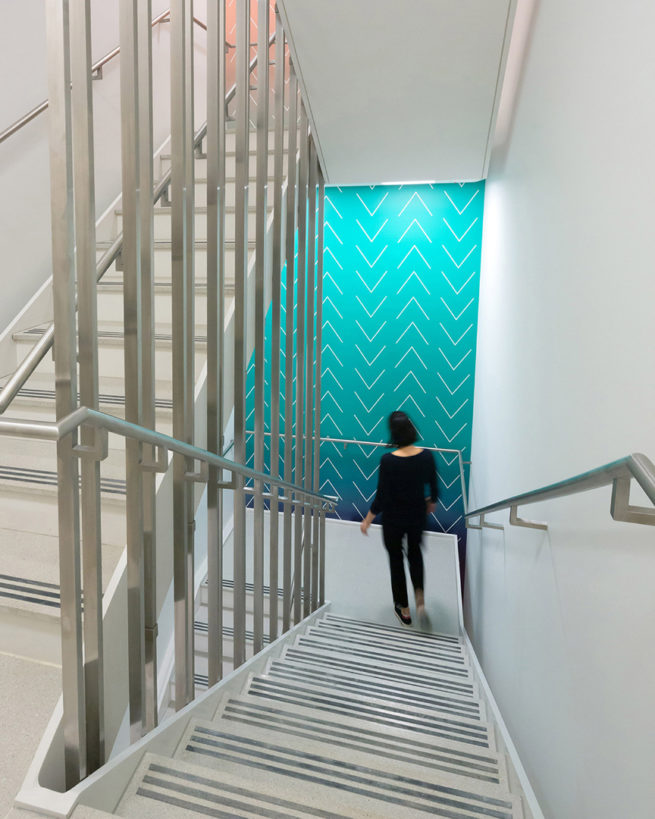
xmin=0 ymin=0 xmax=206 ymax=340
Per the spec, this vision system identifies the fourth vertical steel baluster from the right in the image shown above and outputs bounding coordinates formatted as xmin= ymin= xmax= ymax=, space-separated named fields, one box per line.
xmin=282 ymin=72 xmax=298 ymax=631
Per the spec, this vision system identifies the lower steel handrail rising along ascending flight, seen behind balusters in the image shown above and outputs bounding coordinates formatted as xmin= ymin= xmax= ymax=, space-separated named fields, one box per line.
xmin=0 ymin=31 xmax=275 ymax=415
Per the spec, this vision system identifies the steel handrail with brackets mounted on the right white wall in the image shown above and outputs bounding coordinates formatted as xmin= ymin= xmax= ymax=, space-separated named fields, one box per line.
xmin=466 ymin=453 xmax=655 ymax=529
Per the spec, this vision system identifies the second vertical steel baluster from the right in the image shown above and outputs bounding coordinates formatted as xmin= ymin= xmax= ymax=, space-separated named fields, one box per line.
xmin=303 ymin=138 xmax=317 ymax=617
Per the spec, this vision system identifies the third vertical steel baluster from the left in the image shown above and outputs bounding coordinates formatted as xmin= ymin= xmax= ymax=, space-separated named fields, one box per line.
xmin=120 ymin=0 xmax=145 ymax=741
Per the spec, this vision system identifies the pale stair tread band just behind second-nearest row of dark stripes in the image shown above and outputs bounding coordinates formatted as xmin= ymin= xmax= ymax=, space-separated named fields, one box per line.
xmin=182 ymin=716 xmax=511 ymax=800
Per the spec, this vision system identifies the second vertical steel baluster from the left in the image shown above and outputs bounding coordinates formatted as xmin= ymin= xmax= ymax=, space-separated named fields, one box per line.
xmin=70 ymin=0 xmax=105 ymax=774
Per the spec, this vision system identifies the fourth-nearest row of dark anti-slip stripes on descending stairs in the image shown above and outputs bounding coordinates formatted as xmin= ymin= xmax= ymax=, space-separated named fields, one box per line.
xmin=247 ymin=679 xmax=488 ymax=740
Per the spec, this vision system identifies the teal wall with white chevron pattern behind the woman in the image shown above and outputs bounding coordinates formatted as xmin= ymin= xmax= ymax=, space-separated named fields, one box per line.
xmin=248 ymin=182 xmax=484 ymax=535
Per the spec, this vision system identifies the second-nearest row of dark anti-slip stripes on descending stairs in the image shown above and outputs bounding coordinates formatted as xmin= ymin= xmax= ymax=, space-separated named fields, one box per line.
xmin=186 ymin=740 xmax=512 ymax=819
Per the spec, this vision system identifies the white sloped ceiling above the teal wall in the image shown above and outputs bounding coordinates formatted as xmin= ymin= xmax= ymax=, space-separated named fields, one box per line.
xmin=278 ymin=0 xmax=515 ymax=185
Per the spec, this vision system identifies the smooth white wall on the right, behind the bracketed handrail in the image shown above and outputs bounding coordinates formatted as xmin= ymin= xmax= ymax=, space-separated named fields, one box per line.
xmin=465 ymin=0 xmax=655 ymax=819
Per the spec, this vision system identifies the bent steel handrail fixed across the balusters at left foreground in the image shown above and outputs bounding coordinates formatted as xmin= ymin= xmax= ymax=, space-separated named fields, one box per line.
xmin=0 ymin=407 xmax=335 ymax=511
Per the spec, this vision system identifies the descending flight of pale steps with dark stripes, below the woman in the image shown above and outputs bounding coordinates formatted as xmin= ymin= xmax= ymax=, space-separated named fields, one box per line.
xmin=111 ymin=614 xmax=528 ymax=819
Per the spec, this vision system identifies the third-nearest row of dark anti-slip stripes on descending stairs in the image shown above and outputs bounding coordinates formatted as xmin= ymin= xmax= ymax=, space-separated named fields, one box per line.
xmin=221 ymin=708 xmax=500 ymax=785
